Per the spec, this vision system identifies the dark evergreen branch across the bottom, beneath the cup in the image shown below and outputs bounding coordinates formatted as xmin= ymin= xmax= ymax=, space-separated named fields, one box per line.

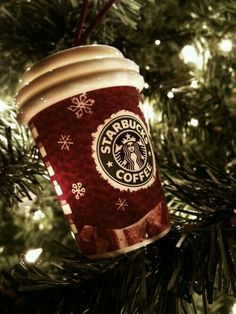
xmin=1 ymin=224 xmax=236 ymax=314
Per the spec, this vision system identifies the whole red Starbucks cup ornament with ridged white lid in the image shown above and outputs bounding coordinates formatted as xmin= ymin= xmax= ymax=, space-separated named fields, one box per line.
xmin=16 ymin=45 xmax=170 ymax=258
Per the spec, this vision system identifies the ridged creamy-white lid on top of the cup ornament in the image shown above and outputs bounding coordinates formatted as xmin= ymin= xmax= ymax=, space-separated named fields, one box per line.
xmin=16 ymin=45 xmax=144 ymax=124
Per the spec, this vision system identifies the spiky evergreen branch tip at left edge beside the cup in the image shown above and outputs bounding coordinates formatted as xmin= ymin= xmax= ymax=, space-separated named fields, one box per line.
xmin=0 ymin=123 xmax=45 ymax=206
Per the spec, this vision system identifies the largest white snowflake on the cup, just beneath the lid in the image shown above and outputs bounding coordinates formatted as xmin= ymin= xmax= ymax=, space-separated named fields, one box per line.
xmin=67 ymin=93 xmax=95 ymax=119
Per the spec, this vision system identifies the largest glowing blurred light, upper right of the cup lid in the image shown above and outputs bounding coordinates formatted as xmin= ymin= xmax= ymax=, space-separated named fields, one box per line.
xmin=180 ymin=45 xmax=210 ymax=69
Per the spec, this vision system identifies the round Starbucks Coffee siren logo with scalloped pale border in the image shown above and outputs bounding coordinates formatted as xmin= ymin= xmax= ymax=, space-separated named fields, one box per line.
xmin=92 ymin=110 xmax=156 ymax=191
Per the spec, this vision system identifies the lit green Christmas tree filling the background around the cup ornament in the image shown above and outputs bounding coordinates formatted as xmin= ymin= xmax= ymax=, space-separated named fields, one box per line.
xmin=0 ymin=0 xmax=236 ymax=314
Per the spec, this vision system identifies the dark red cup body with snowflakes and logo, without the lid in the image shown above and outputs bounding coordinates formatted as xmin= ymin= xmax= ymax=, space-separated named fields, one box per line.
xmin=29 ymin=86 xmax=170 ymax=257
